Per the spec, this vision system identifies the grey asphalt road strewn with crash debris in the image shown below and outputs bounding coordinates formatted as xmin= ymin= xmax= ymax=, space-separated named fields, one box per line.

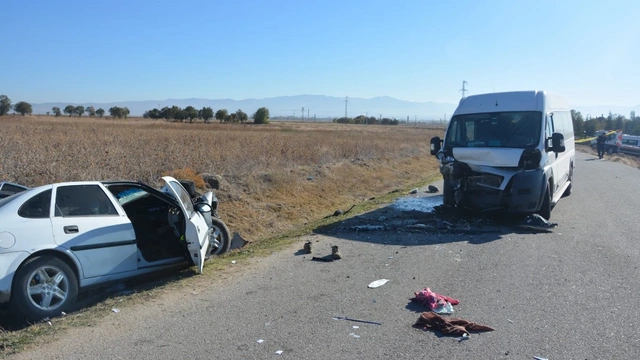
xmin=10 ymin=153 xmax=640 ymax=359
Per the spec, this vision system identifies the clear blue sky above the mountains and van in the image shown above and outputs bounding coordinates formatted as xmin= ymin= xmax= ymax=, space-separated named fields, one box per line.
xmin=0 ymin=0 xmax=640 ymax=106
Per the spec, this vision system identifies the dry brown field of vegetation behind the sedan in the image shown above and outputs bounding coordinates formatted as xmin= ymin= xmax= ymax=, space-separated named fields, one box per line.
xmin=0 ymin=116 xmax=443 ymax=241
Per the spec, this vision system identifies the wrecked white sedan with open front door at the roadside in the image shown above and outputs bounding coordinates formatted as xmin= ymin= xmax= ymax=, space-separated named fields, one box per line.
xmin=0 ymin=177 xmax=230 ymax=321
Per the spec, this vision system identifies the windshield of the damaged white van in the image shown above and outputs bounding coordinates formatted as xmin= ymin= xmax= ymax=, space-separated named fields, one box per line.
xmin=445 ymin=111 xmax=542 ymax=149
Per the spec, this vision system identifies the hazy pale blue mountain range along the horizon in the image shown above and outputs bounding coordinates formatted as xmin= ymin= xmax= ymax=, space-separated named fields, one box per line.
xmin=32 ymin=95 xmax=640 ymax=121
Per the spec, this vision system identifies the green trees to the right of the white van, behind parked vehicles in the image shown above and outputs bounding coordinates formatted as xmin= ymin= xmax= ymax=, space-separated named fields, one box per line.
xmin=571 ymin=110 xmax=640 ymax=136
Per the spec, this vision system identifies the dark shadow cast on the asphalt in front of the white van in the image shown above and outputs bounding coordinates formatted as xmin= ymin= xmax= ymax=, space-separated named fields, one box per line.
xmin=314 ymin=195 xmax=539 ymax=246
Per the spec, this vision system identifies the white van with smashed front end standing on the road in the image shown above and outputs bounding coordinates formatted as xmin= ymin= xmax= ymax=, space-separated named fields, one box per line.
xmin=431 ymin=91 xmax=575 ymax=219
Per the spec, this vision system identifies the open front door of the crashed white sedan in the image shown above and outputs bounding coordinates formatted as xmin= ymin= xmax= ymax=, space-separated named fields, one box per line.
xmin=162 ymin=176 xmax=211 ymax=273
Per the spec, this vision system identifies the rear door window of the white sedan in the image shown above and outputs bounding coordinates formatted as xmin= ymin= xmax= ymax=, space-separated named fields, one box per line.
xmin=56 ymin=185 xmax=118 ymax=217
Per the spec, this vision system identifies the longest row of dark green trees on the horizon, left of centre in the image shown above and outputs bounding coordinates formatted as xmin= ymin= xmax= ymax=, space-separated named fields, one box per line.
xmin=142 ymin=105 xmax=269 ymax=124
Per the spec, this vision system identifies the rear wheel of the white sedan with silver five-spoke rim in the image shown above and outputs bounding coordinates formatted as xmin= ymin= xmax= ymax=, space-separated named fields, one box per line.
xmin=11 ymin=255 xmax=78 ymax=322
